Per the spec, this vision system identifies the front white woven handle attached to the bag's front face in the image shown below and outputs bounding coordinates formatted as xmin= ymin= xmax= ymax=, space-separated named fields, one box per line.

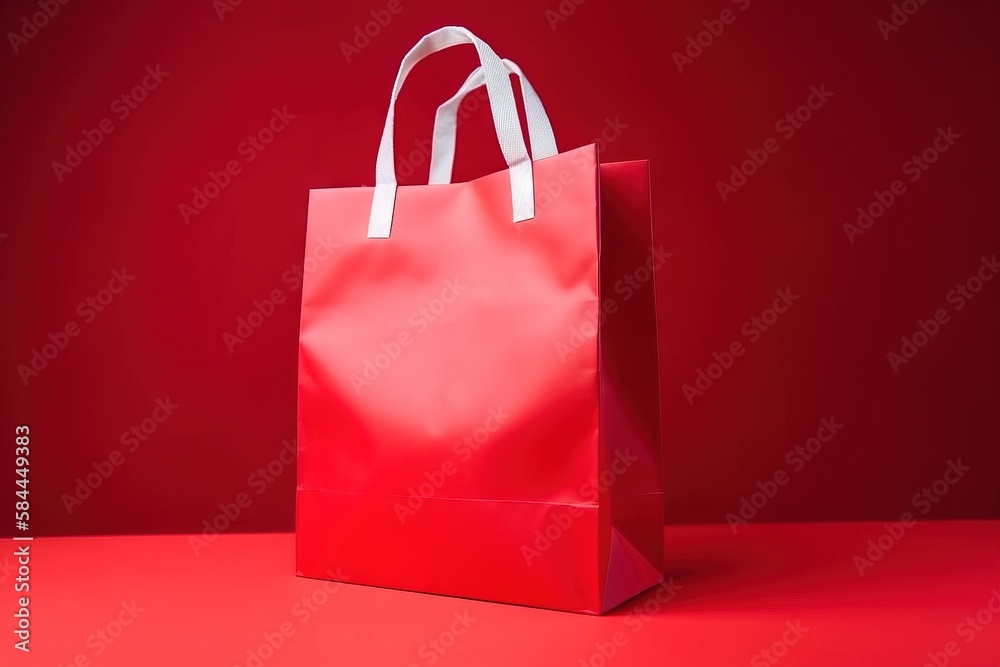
xmin=368 ymin=26 xmax=535 ymax=239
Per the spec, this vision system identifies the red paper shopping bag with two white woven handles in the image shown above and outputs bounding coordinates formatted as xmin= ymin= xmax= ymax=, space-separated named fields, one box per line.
xmin=296 ymin=27 xmax=663 ymax=613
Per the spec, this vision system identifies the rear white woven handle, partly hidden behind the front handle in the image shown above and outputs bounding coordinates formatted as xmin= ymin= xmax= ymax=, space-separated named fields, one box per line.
xmin=429 ymin=58 xmax=559 ymax=184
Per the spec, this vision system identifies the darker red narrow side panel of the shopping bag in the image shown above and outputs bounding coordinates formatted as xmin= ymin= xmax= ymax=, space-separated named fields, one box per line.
xmin=598 ymin=160 xmax=665 ymax=611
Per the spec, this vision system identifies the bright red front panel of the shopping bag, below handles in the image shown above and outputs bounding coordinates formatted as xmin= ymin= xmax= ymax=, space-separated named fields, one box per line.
xmin=298 ymin=145 xmax=599 ymax=611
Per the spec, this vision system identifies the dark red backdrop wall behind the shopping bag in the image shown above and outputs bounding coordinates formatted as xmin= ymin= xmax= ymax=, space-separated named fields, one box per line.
xmin=0 ymin=0 xmax=1000 ymax=534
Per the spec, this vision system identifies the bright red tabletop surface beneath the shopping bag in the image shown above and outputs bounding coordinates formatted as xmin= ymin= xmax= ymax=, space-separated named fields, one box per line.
xmin=11 ymin=522 xmax=1000 ymax=667
